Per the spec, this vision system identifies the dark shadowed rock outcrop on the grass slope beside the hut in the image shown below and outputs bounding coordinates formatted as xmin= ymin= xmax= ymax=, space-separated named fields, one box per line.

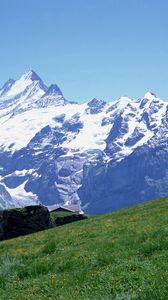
xmin=0 ymin=205 xmax=87 ymax=241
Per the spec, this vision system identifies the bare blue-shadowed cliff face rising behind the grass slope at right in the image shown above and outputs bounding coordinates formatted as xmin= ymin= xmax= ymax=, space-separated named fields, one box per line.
xmin=79 ymin=125 xmax=168 ymax=214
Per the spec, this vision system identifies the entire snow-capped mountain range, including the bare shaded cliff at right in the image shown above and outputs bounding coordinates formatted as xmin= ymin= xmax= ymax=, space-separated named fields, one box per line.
xmin=0 ymin=71 xmax=168 ymax=213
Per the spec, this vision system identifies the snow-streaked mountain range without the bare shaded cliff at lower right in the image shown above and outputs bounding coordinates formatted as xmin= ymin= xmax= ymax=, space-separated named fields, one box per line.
xmin=0 ymin=70 xmax=168 ymax=211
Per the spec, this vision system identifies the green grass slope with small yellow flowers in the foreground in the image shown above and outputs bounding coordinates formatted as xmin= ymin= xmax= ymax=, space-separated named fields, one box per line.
xmin=0 ymin=198 xmax=168 ymax=300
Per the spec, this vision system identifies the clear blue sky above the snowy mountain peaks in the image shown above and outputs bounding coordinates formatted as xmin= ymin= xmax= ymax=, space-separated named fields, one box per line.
xmin=0 ymin=0 xmax=168 ymax=102
